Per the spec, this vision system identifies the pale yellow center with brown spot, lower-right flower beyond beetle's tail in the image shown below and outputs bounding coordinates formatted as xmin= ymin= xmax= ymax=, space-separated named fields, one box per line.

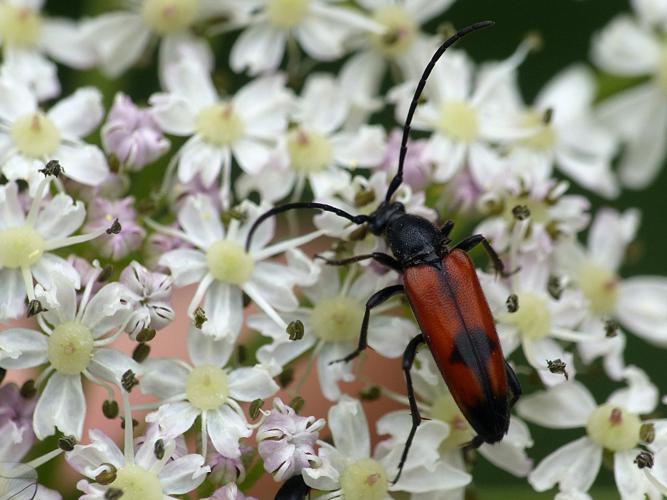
xmin=586 ymin=404 xmax=642 ymax=452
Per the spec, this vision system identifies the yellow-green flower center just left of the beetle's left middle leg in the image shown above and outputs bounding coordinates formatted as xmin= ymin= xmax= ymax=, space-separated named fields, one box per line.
xmin=310 ymin=295 xmax=364 ymax=342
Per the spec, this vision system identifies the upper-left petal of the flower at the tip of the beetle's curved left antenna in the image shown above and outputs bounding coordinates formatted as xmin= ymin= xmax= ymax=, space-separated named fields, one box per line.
xmin=178 ymin=194 xmax=224 ymax=248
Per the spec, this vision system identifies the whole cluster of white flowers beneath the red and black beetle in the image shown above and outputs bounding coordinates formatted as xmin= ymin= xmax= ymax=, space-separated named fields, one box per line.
xmin=0 ymin=0 xmax=667 ymax=500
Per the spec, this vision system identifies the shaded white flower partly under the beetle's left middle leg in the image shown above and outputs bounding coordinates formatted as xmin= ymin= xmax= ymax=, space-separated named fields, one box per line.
xmin=248 ymin=266 xmax=417 ymax=401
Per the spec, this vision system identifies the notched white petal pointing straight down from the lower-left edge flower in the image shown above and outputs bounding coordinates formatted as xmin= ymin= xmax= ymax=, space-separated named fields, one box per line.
xmin=33 ymin=372 xmax=86 ymax=440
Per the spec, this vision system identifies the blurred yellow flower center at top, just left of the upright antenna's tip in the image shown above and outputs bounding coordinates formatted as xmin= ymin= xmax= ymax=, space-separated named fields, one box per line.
xmin=370 ymin=5 xmax=418 ymax=57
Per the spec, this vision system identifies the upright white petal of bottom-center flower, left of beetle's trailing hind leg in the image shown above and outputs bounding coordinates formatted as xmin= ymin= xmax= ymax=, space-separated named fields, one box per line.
xmin=328 ymin=395 xmax=371 ymax=460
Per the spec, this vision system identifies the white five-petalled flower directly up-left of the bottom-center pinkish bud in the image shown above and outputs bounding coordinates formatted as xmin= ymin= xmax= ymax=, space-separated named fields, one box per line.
xmin=140 ymin=328 xmax=278 ymax=458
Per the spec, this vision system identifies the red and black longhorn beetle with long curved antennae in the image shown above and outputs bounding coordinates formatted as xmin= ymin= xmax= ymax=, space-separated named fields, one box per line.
xmin=246 ymin=21 xmax=521 ymax=488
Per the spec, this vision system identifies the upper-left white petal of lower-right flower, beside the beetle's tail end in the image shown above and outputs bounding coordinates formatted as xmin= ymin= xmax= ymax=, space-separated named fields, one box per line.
xmin=517 ymin=381 xmax=597 ymax=429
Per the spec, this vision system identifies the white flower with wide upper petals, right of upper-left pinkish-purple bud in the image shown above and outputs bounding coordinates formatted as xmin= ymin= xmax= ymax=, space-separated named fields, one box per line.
xmin=150 ymin=60 xmax=290 ymax=206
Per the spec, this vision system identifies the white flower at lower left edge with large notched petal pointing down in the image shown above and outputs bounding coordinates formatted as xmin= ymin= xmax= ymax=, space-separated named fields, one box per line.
xmin=0 ymin=272 xmax=139 ymax=439
